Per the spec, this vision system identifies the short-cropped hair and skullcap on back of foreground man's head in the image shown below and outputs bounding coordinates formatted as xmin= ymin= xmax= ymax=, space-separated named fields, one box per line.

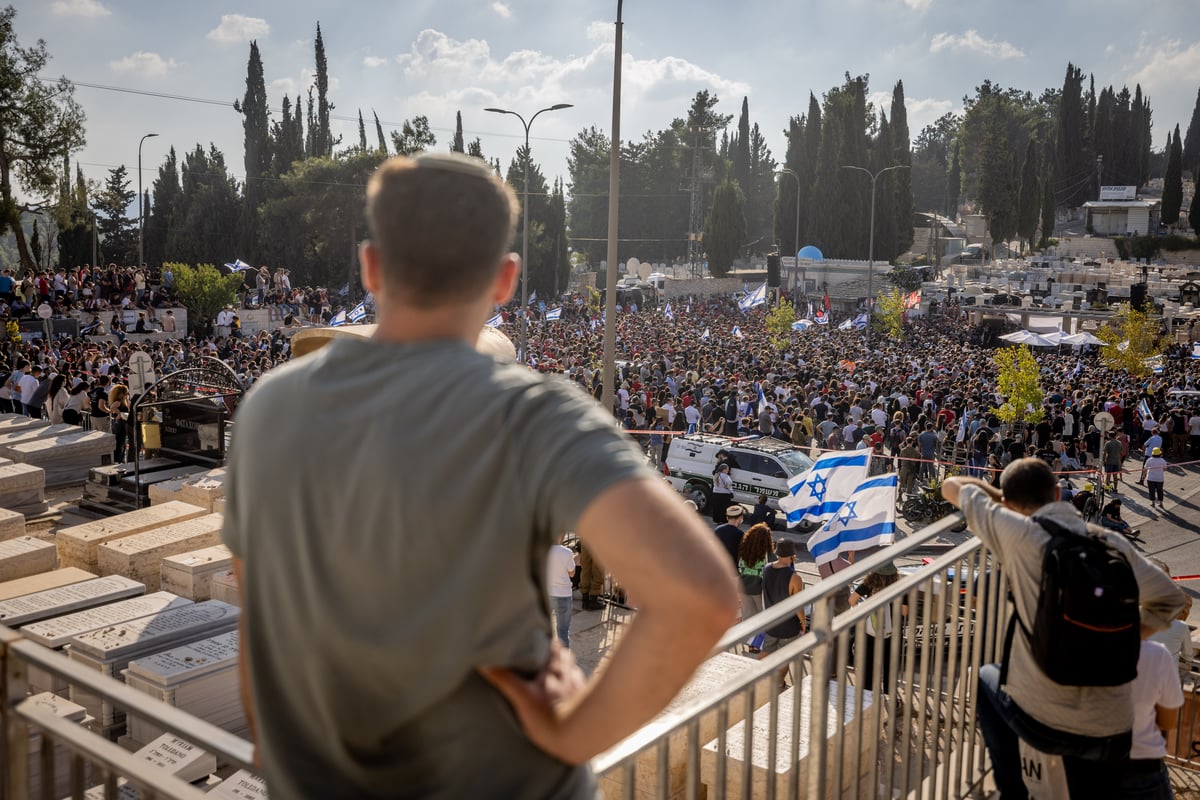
xmin=366 ymin=154 xmax=520 ymax=306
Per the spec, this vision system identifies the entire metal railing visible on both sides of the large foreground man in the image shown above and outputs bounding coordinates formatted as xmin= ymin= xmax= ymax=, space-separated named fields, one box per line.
xmin=0 ymin=515 xmax=993 ymax=800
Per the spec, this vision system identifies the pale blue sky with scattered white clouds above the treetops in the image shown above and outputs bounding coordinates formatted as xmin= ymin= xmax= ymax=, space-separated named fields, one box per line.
xmin=14 ymin=0 xmax=1200 ymax=200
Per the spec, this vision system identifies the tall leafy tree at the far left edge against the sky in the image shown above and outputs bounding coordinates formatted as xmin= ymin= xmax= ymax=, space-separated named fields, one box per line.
xmin=0 ymin=6 xmax=84 ymax=267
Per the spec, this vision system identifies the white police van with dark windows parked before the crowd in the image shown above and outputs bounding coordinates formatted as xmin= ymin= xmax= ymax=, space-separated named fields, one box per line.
xmin=664 ymin=433 xmax=812 ymax=522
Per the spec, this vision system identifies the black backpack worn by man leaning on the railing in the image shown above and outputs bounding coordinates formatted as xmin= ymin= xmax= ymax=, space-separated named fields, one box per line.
xmin=1001 ymin=518 xmax=1141 ymax=686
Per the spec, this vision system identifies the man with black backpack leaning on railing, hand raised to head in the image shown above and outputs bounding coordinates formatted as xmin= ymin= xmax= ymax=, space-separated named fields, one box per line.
xmin=942 ymin=458 xmax=1186 ymax=800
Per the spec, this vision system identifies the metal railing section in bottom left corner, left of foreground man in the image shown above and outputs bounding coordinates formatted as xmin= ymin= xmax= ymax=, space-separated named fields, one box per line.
xmin=0 ymin=626 xmax=253 ymax=800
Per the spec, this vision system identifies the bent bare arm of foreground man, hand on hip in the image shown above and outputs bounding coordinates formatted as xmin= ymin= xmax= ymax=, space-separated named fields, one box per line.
xmin=484 ymin=479 xmax=739 ymax=764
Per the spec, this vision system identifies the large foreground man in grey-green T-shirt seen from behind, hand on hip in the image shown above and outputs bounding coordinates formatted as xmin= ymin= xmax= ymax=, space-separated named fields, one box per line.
xmin=222 ymin=154 xmax=738 ymax=800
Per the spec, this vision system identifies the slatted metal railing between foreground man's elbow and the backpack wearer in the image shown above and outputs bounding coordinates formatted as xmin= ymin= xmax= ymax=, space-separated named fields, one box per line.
xmin=593 ymin=515 xmax=1008 ymax=800
